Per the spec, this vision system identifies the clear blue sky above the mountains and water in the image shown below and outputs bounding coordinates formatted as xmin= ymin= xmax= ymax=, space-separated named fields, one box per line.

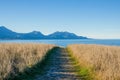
xmin=0 ymin=0 xmax=120 ymax=39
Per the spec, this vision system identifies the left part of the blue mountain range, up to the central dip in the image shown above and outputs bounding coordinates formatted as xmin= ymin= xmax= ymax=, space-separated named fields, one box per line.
xmin=0 ymin=26 xmax=45 ymax=39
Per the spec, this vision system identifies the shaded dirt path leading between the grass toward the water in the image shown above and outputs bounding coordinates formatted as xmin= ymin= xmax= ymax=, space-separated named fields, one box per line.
xmin=35 ymin=48 xmax=81 ymax=80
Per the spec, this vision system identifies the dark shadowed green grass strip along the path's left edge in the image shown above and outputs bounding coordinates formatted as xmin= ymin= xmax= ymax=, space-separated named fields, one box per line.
xmin=7 ymin=47 xmax=58 ymax=80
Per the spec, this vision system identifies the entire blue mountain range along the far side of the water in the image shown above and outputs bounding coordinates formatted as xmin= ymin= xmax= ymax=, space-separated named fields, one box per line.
xmin=0 ymin=26 xmax=88 ymax=39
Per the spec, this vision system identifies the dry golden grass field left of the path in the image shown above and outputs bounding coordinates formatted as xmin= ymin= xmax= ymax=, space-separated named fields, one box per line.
xmin=0 ymin=43 xmax=54 ymax=80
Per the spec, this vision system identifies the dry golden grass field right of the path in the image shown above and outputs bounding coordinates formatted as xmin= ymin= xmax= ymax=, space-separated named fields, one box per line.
xmin=68 ymin=44 xmax=120 ymax=80
